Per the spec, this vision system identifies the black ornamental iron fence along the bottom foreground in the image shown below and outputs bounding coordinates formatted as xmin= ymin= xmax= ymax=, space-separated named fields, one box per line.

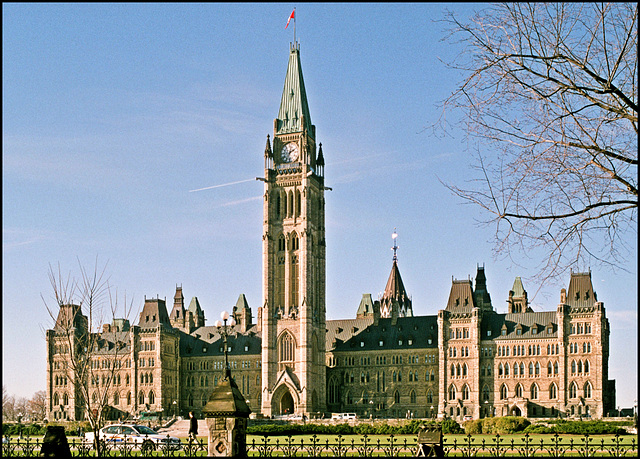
xmin=2 ymin=434 xmax=638 ymax=457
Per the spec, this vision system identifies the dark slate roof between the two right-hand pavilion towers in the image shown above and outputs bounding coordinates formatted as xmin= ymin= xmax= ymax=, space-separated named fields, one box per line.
xmin=481 ymin=311 xmax=558 ymax=340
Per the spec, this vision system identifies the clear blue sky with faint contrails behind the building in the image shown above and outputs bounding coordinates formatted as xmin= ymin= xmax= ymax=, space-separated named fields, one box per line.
xmin=2 ymin=3 xmax=637 ymax=406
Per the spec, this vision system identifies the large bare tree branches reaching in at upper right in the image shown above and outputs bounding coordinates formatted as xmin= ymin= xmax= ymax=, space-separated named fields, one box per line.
xmin=441 ymin=2 xmax=638 ymax=279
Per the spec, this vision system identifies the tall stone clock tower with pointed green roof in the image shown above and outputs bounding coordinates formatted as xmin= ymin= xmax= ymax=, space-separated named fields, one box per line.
xmin=261 ymin=42 xmax=326 ymax=416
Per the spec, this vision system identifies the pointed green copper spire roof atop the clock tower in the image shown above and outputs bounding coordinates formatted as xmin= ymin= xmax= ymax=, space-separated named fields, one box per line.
xmin=276 ymin=43 xmax=313 ymax=134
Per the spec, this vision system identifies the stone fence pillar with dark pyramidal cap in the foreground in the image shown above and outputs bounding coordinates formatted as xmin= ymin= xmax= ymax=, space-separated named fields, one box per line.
xmin=202 ymin=370 xmax=251 ymax=457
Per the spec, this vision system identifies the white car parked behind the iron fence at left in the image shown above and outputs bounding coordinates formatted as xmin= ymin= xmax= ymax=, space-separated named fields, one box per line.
xmin=84 ymin=424 xmax=182 ymax=454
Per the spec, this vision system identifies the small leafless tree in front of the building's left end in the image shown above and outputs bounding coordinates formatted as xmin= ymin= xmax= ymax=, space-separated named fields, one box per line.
xmin=43 ymin=259 xmax=132 ymax=455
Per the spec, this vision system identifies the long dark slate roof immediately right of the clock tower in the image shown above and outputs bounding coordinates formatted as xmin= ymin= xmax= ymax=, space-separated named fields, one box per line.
xmin=327 ymin=316 xmax=438 ymax=352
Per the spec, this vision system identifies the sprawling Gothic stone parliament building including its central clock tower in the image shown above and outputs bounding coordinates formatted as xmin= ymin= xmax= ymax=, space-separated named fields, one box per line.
xmin=46 ymin=43 xmax=615 ymax=420
